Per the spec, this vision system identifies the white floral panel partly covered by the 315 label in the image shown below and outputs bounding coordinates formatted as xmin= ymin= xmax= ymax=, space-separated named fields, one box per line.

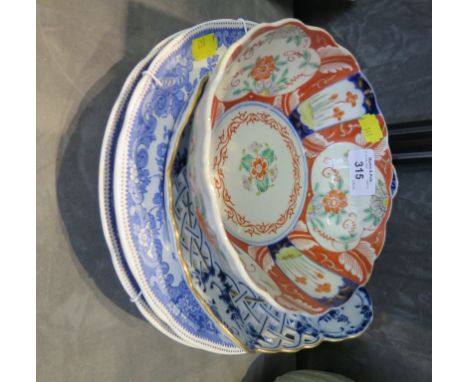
xmin=307 ymin=142 xmax=389 ymax=252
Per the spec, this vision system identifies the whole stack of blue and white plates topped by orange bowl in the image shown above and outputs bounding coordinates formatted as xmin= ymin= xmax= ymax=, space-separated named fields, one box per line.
xmin=99 ymin=19 xmax=397 ymax=354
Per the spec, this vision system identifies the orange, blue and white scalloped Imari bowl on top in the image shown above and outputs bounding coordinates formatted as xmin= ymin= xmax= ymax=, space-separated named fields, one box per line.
xmin=187 ymin=19 xmax=393 ymax=315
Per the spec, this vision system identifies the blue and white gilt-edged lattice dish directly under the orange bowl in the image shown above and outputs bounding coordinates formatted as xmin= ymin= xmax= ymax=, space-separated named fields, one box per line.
xmin=165 ymin=120 xmax=372 ymax=352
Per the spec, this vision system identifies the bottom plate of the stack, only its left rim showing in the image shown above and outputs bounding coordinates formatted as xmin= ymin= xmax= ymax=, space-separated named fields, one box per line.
xmin=99 ymin=32 xmax=192 ymax=346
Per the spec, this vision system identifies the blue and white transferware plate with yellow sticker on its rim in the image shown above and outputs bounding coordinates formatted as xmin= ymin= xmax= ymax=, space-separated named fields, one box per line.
xmin=114 ymin=20 xmax=260 ymax=353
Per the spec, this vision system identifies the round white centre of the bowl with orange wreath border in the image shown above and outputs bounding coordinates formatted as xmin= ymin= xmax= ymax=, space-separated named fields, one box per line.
xmin=211 ymin=102 xmax=307 ymax=245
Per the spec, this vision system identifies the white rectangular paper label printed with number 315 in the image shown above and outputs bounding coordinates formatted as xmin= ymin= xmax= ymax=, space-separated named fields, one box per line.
xmin=348 ymin=149 xmax=375 ymax=195
